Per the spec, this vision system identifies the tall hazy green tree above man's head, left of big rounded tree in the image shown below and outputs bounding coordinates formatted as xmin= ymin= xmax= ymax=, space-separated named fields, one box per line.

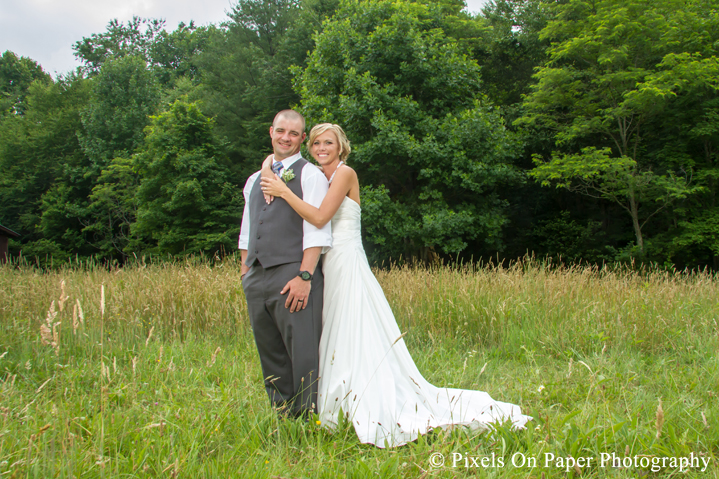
xmin=195 ymin=0 xmax=321 ymax=178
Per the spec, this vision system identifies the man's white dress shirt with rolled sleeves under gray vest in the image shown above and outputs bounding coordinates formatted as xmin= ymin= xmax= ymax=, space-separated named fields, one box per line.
xmin=239 ymin=153 xmax=332 ymax=253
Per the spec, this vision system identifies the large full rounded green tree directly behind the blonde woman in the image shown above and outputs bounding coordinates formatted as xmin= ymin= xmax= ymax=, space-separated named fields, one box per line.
xmin=298 ymin=1 xmax=519 ymax=259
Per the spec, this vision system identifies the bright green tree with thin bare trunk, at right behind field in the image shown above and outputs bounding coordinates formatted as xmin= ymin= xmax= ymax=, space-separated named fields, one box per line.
xmin=516 ymin=0 xmax=698 ymax=253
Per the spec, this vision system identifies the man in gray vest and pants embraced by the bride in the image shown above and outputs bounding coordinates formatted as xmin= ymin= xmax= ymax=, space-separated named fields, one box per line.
xmin=239 ymin=110 xmax=332 ymax=416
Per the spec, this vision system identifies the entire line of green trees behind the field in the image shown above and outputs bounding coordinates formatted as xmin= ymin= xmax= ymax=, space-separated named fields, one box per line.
xmin=0 ymin=0 xmax=719 ymax=270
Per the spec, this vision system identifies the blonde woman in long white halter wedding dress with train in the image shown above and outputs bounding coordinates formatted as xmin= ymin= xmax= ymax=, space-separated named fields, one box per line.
xmin=261 ymin=123 xmax=531 ymax=447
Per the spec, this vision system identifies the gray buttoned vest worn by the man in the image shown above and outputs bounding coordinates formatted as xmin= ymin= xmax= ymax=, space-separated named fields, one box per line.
xmin=245 ymin=158 xmax=307 ymax=268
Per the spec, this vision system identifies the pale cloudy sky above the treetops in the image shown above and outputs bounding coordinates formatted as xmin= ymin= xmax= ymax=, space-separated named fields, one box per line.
xmin=0 ymin=0 xmax=484 ymax=77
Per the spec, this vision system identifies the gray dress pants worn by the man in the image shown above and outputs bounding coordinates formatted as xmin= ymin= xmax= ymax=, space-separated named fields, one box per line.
xmin=242 ymin=261 xmax=324 ymax=416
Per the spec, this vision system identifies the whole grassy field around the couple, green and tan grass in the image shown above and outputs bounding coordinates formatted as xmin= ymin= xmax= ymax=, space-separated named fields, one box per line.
xmin=0 ymin=260 xmax=719 ymax=478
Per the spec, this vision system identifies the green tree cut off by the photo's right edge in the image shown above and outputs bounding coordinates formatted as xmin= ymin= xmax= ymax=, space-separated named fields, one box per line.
xmin=629 ymin=53 xmax=719 ymax=268
